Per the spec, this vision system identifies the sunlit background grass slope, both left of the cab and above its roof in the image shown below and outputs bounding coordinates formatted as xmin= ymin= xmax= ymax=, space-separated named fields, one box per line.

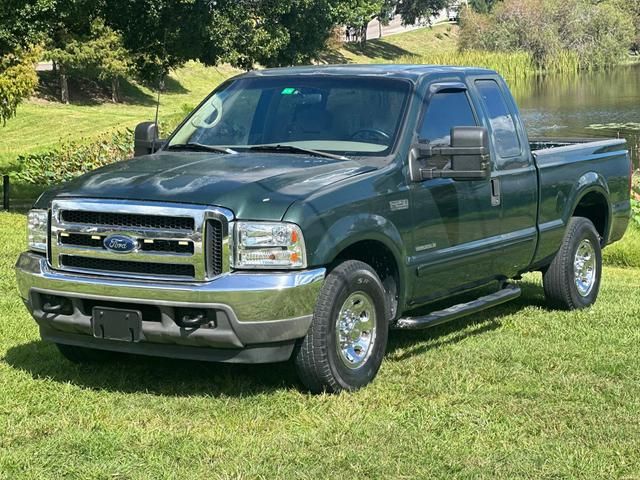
xmin=0 ymin=25 xmax=457 ymax=173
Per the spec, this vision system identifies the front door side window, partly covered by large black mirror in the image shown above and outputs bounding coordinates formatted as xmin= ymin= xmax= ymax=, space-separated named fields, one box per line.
xmin=420 ymin=92 xmax=477 ymax=145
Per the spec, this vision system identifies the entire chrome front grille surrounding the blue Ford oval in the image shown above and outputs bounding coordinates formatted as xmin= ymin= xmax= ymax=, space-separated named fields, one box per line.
xmin=49 ymin=199 xmax=233 ymax=281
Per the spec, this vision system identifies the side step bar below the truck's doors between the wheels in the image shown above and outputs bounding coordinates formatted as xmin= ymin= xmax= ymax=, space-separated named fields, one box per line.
xmin=394 ymin=285 xmax=522 ymax=330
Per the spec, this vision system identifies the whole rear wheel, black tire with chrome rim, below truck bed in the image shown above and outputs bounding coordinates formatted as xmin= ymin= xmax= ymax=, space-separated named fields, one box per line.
xmin=542 ymin=217 xmax=602 ymax=310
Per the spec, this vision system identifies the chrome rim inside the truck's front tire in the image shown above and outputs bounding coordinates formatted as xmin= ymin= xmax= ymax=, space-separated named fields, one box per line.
xmin=336 ymin=292 xmax=376 ymax=369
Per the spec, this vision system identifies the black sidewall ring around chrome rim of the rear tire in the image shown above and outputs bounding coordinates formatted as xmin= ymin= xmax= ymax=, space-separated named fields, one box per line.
xmin=565 ymin=218 xmax=602 ymax=308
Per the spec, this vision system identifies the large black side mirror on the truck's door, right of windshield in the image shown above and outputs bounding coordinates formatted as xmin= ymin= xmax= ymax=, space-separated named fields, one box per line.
xmin=410 ymin=127 xmax=491 ymax=181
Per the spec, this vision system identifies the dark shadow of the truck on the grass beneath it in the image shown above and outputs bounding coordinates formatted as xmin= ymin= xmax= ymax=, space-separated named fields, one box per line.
xmin=4 ymin=282 xmax=545 ymax=397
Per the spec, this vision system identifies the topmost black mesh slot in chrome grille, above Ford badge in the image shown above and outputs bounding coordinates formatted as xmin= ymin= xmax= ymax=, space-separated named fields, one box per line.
xmin=61 ymin=210 xmax=194 ymax=230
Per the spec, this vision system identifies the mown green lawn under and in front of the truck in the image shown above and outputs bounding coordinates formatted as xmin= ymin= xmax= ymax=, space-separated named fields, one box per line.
xmin=0 ymin=213 xmax=640 ymax=480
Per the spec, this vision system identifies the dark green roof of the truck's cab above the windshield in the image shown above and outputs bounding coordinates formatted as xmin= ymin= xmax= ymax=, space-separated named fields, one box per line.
xmin=240 ymin=64 xmax=496 ymax=80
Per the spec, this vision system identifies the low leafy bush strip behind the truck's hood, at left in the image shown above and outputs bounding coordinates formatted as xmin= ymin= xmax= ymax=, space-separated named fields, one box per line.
xmin=13 ymin=129 xmax=133 ymax=185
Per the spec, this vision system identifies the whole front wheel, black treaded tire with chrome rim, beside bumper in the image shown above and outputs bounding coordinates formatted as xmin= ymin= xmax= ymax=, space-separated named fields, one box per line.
xmin=293 ymin=260 xmax=389 ymax=393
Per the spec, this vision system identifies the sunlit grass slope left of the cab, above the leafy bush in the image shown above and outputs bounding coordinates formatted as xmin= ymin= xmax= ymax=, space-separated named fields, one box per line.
xmin=0 ymin=62 xmax=236 ymax=171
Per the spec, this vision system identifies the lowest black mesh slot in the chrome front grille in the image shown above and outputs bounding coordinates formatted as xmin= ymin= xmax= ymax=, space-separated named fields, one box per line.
xmin=60 ymin=255 xmax=195 ymax=277
